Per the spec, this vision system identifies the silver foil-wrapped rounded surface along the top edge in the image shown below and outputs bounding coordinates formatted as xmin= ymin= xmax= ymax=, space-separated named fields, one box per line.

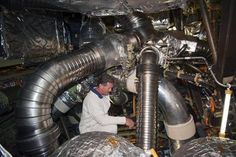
xmin=47 ymin=0 xmax=187 ymax=16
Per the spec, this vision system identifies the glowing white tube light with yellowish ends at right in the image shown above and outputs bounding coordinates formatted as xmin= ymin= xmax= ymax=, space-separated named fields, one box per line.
xmin=219 ymin=88 xmax=232 ymax=138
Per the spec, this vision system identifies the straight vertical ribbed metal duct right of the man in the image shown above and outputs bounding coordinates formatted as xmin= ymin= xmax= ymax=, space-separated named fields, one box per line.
xmin=136 ymin=47 xmax=159 ymax=151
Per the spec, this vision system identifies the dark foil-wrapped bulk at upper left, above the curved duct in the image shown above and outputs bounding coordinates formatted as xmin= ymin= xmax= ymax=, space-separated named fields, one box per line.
xmin=0 ymin=11 xmax=69 ymax=62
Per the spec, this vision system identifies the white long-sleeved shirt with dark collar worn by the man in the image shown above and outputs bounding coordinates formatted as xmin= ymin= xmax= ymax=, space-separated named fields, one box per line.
xmin=79 ymin=91 xmax=126 ymax=134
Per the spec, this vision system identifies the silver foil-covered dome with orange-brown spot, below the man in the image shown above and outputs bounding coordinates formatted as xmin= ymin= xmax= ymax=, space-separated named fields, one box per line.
xmin=52 ymin=132 xmax=145 ymax=157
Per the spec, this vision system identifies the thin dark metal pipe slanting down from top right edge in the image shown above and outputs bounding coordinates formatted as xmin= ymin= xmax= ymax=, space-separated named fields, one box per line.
xmin=199 ymin=0 xmax=217 ymax=64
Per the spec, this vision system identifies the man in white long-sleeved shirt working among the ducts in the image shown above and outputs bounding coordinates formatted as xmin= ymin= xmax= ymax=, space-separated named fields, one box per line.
xmin=79 ymin=75 xmax=134 ymax=134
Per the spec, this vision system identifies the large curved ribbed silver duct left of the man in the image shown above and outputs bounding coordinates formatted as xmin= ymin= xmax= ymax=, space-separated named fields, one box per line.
xmin=16 ymin=48 xmax=105 ymax=156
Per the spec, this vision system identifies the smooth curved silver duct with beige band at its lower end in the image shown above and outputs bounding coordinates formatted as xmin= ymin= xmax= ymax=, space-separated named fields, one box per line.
xmin=158 ymin=78 xmax=196 ymax=152
